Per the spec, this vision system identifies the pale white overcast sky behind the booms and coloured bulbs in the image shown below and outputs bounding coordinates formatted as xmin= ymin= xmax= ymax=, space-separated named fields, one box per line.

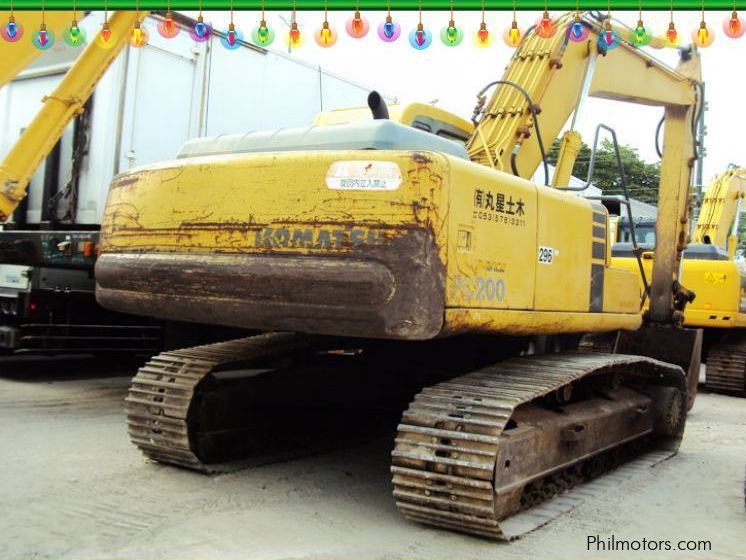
xmin=215 ymin=10 xmax=746 ymax=182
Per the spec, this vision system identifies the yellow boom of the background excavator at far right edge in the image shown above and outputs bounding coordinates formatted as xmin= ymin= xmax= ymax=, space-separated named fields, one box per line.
xmin=692 ymin=167 xmax=746 ymax=250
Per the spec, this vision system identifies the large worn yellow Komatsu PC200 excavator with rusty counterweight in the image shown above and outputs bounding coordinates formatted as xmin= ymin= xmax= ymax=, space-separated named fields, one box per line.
xmin=96 ymin=15 xmax=702 ymax=539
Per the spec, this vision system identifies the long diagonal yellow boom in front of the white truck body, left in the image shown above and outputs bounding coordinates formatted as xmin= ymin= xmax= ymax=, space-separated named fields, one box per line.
xmin=0 ymin=12 xmax=144 ymax=223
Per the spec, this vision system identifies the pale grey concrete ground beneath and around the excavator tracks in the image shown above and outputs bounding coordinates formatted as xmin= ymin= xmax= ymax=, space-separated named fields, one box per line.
xmin=0 ymin=360 xmax=746 ymax=560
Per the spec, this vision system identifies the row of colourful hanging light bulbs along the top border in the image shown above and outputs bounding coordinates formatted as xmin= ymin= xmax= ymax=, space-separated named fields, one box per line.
xmin=0 ymin=0 xmax=746 ymax=51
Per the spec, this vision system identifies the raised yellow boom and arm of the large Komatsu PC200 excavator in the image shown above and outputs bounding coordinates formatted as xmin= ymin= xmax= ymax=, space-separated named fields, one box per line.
xmin=467 ymin=14 xmax=702 ymax=323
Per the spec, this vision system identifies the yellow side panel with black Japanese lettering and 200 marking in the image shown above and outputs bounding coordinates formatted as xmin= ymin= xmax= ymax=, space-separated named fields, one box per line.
xmin=446 ymin=160 xmax=538 ymax=309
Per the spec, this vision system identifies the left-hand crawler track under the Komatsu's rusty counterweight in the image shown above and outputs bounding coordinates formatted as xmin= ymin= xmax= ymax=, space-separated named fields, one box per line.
xmin=126 ymin=333 xmax=302 ymax=472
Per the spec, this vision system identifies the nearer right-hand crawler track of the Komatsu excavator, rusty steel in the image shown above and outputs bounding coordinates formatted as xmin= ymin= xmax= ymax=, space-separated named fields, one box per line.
xmin=391 ymin=353 xmax=686 ymax=540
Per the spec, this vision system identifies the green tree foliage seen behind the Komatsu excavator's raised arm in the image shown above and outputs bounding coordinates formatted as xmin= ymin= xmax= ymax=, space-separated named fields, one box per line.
xmin=547 ymin=139 xmax=660 ymax=204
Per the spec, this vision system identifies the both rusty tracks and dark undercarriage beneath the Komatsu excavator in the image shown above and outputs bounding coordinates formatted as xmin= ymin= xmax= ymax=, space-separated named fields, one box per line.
xmin=127 ymin=333 xmax=687 ymax=539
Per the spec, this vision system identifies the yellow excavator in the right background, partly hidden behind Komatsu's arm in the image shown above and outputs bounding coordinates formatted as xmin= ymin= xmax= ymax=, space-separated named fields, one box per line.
xmin=612 ymin=166 xmax=746 ymax=397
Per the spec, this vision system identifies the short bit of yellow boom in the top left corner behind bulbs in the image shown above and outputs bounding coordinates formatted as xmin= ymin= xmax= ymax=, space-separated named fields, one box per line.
xmin=0 ymin=11 xmax=73 ymax=87
